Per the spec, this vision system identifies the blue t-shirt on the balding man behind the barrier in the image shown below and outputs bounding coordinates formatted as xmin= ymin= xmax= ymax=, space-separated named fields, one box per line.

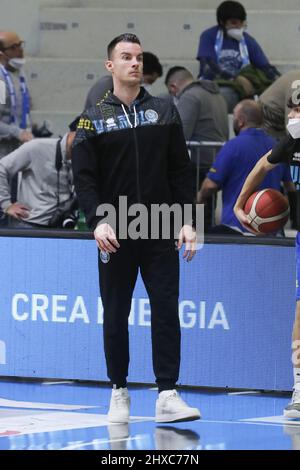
xmin=207 ymin=128 xmax=291 ymax=232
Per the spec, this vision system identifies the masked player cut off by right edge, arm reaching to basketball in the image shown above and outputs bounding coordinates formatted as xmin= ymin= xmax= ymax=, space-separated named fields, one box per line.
xmin=234 ymin=99 xmax=300 ymax=418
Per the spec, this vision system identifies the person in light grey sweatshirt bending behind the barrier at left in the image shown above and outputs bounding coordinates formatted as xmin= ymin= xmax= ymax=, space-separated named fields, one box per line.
xmin=0 ymin=131 xmax=76 ymax=229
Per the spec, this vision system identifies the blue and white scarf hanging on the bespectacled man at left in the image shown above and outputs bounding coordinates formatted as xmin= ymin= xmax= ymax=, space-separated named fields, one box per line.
xmin=0 ymin=65 xmax=30 ymax=129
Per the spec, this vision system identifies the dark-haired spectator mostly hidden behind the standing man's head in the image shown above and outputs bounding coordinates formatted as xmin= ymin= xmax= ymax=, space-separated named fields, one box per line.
xmin=84 ymin=52 xmax=163 ymax=109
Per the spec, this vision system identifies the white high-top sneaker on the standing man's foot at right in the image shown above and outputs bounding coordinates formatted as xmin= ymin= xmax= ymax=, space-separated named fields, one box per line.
xmin=155 ymin=390 xmax=201 ymax=423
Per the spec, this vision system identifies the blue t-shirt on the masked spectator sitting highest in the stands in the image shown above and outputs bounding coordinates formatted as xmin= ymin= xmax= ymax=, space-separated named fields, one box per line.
xmin=197 ymin=26 xmax=269 ymax=80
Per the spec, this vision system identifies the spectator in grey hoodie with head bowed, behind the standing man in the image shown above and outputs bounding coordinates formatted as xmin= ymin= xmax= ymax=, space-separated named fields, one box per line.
xmin=166 ymin=67 xmax=229 ymax=225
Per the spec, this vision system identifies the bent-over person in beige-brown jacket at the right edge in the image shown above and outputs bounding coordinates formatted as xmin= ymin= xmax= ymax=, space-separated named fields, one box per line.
xmin=259 ymin=70 xmax=300 ymax=138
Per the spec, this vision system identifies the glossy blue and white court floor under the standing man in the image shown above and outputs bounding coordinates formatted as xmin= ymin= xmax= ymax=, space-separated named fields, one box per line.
xmin=0 ymin=381 xmax=300 ymax=451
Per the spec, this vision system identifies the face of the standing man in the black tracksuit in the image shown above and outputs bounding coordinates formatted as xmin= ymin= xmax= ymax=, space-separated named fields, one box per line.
xmin=106 ymin=42 xmax=143 ymax=85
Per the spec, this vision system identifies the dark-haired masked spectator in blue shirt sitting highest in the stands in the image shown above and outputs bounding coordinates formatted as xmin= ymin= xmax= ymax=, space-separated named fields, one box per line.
xmin=197 ymin=1 xmax=279 ymax=113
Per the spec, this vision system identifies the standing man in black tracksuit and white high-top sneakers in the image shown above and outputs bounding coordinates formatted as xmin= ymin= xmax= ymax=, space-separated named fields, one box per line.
xmin=72 ymin=34 xmax=200 ymax=423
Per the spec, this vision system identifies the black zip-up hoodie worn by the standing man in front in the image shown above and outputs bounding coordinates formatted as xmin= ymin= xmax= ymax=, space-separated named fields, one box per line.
xmin=72 ymin=88 xmax=195 ymax=228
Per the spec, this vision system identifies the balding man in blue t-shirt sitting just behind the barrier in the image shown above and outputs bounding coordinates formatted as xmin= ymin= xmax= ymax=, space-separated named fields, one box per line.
xmin=199 ymin=100 xmax=296 ymax=233
